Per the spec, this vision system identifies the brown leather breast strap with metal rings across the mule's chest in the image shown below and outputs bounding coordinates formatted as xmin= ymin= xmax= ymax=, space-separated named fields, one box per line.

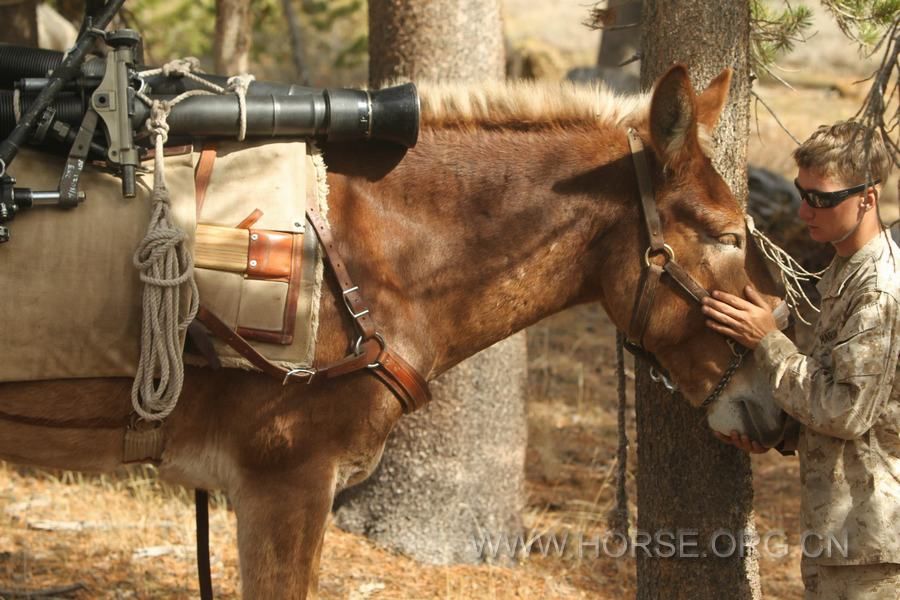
xmin=197 ymin=208 xmax=431 ymax=413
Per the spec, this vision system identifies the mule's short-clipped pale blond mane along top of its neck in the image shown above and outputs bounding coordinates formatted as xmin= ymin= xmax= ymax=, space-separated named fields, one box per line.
xmin=418 ymin=81 xmax=650 ymax=129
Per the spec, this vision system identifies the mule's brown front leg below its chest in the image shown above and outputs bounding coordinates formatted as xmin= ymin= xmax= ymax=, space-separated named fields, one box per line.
xmin=233 ymin=464 xmax=335 ymax=600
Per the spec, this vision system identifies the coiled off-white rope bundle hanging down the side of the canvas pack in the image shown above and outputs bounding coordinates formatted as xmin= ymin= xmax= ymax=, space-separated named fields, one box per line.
xmin=131 ymin=101 xmax=199 ymax=421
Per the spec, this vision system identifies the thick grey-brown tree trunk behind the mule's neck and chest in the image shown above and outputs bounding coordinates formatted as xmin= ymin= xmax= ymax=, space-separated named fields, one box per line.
xmin=336 ymin=0 xmax=526 ymax=563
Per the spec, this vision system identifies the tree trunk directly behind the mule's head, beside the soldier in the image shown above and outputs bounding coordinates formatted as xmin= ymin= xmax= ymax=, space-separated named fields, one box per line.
xmin=636 ymin=0 xmax=760 ymax=600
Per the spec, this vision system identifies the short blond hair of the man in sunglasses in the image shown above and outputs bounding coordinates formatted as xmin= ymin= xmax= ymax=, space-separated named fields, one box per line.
xmin=794 ymin=121 xmax=891 ymax=185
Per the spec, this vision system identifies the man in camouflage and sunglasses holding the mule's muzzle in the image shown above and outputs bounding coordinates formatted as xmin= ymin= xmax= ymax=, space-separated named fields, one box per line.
xmin=703 ymin=122 xmax=900 ymax=600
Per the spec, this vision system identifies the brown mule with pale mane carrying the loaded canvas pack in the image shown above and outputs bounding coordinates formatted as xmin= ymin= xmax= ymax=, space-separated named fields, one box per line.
xmin=0 ymin=67 xmax=777 ymax=598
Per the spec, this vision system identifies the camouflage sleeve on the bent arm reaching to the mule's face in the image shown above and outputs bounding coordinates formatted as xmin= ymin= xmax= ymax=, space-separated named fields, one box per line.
xmin=754 ymin=292 xmax=900 ymax=440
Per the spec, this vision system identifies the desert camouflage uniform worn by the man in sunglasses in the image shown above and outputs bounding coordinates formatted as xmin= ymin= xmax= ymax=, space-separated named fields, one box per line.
xmin=755 ymin=235 xmax=900 ymax=598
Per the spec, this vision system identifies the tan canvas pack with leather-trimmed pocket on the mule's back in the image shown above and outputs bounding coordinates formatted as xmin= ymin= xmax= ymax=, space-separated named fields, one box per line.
xmin=0 ymin=141 xmax=327 ymax=381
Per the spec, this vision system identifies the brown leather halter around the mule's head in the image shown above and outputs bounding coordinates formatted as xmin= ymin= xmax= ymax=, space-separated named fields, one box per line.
xmin=625 ymin=129 xmax=749 ymax=407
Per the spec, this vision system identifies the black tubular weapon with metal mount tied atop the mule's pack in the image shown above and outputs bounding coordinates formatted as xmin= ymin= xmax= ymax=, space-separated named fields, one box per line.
xmin=0 ymin=0 xmax=419 ymax=243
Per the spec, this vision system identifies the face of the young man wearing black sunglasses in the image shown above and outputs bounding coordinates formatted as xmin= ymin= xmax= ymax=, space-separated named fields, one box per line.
xmin=797 ymin=169 xmax=865 ymax=243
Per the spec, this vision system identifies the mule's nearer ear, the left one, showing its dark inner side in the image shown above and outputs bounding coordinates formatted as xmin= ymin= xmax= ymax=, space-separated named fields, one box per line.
xmin=650 ymin=65 xmax=697 ymax=163
